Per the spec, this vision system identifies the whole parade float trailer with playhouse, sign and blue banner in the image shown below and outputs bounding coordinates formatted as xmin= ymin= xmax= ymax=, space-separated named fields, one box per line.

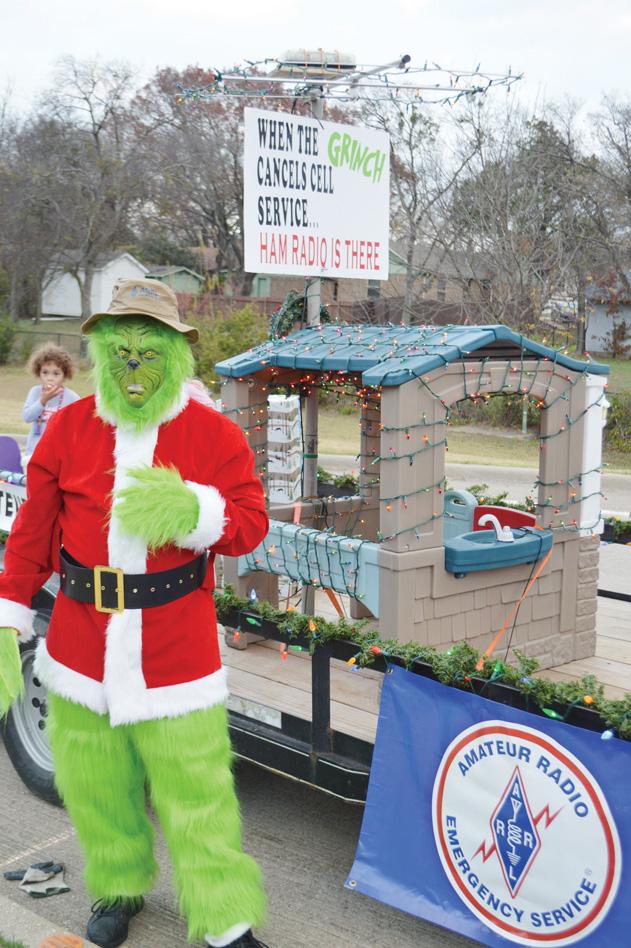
xmin=4 ymin=51 xmax=631 ymax=948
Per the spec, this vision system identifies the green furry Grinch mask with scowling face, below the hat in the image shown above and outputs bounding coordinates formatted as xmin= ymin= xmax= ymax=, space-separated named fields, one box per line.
xmin=88 ymin=316 xmax=193 ymax=429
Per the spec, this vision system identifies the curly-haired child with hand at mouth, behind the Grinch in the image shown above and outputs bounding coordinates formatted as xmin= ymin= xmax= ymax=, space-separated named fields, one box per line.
xmin=22 ymin=343 xmax=79 ymax=463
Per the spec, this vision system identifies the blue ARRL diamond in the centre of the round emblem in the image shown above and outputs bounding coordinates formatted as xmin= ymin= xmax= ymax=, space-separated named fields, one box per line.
xmin=491 ymin=767 xmax=541 ymax=895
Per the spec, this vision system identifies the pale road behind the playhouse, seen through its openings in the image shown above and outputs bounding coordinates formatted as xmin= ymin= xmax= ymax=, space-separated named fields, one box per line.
xmin=319 ymin=454 xmax=631 ymax=518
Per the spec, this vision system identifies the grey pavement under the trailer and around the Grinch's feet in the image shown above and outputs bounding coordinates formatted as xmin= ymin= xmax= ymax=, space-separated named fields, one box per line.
xmin=0 ymin=742 xmax=477 ymax=948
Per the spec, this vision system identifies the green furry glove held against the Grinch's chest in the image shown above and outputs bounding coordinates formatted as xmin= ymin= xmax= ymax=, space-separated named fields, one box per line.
xmin=113 ymin=467 xmax=199 ymax=550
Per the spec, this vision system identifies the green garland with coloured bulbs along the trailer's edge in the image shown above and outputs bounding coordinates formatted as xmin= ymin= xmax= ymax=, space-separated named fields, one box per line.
xmin=215 ymin=586 xmax=631 ymax=740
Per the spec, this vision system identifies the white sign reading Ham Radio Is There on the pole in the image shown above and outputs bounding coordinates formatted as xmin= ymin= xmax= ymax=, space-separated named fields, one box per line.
xmin=243 ymin=109 xmax=390 ymax=280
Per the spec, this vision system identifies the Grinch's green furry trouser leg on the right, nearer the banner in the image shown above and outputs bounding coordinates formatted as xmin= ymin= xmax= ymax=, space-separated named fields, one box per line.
xmin=133 ymin=705 xmax=266 ymax=941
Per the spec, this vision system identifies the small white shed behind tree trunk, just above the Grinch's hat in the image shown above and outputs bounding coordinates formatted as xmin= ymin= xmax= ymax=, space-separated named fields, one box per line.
xmin=42 ymin=250 xmax=147 ymax=318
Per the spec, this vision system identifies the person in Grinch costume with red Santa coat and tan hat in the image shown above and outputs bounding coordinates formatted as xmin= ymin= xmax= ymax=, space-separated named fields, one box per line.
xmin=0 ymin=279 xmax=268 ymax=948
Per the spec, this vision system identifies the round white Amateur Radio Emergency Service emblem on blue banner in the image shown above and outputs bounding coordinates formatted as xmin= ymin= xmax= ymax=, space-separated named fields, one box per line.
xmin=432 ymin=721 xmax=621 ymax=948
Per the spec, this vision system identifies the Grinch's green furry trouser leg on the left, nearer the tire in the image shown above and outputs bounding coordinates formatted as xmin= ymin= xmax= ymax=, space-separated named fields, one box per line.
xmin=47 ymin=693 xmax=157 ymax=899
